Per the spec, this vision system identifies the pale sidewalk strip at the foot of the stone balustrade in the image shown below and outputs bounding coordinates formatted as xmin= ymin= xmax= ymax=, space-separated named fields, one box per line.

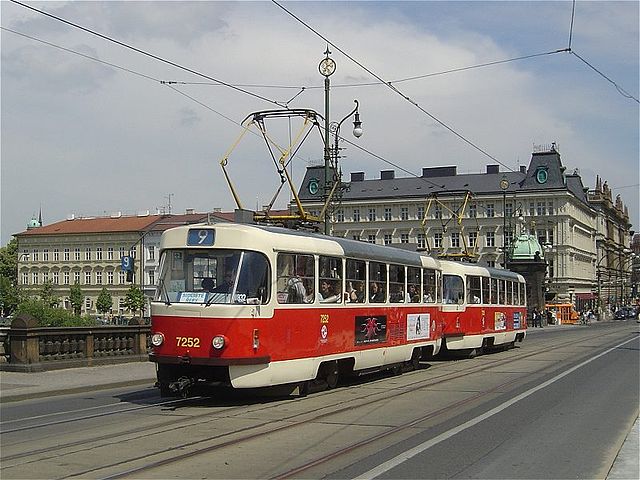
xmin=0 ymin=362 xmax=156 ymax=403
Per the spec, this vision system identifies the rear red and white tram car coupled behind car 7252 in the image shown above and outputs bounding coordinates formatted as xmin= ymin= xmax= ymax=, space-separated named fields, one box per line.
xmin=439 ymin=261 xmax=527 ymax=356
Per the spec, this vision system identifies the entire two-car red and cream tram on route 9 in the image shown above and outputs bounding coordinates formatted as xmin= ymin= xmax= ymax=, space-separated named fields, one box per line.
xmin=150 ymin=223 xmax=526 ymax=396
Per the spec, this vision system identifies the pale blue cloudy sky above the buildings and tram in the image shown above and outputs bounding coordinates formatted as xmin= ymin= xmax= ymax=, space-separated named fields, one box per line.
xmin=0 ymin=0 xmax=640 ymax=245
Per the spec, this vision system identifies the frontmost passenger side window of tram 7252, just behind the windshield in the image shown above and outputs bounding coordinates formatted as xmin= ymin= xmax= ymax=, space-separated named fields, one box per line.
xmin=276 ymin=253 xmax=315 ymax=303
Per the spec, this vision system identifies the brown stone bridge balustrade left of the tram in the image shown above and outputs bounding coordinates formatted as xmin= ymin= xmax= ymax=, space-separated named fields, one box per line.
xmin=0 ymin=315 xmax=151 ymax=372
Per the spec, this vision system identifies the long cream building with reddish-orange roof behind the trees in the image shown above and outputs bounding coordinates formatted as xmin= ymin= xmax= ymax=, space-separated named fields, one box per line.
xmin=15 ymin=212 xmax=222 ymax=315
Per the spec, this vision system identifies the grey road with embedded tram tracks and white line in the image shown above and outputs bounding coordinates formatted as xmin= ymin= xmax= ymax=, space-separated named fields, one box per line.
xmin=0 ymin=322 xmax=640 ymax=479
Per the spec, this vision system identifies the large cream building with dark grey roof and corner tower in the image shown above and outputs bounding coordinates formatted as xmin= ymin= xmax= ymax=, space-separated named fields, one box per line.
xmin=299 ymin=144 xmax=631 ymax=306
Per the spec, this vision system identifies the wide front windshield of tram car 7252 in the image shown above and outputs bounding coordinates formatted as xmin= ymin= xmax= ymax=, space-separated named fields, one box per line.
xmin=155 ymin=249 xmax=270 ymax=306
